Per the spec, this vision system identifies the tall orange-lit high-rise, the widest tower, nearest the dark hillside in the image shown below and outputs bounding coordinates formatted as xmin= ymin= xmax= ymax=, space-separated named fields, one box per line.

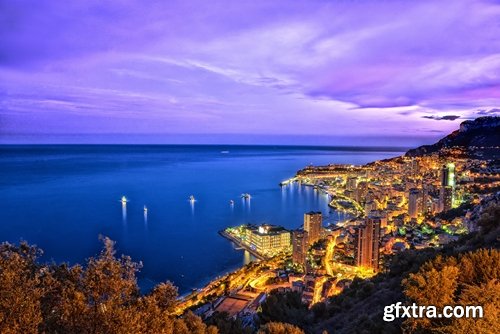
xmin=355 ymin=217 xmax=381 ymax=270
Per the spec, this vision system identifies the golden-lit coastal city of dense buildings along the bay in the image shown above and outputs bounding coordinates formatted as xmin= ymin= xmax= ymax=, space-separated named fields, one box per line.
xmin=176 ymin=118 xmax=500 ymax=326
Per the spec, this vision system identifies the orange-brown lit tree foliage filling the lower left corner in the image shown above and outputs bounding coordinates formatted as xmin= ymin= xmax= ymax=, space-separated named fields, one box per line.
xmin=0 ymin=238 xmax=218 ymax=334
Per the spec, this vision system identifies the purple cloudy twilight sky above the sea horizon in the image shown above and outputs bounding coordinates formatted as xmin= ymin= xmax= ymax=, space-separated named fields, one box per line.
xmin=0 ymin=0 xmax=500 ymax=146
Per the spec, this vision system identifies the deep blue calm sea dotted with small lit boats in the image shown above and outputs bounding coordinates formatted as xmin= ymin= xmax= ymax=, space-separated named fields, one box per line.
xmin=0 ymin=145 xmax=402 ymax=293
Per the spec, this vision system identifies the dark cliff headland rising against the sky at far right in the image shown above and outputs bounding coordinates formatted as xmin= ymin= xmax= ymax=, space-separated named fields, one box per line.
xmin=406 ymin=116 xmax=500 ymax=157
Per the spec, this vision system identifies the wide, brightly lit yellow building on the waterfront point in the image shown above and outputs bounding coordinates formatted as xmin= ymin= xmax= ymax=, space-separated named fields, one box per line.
xmin=244 ymin=224 xmax=291 ymax=257
